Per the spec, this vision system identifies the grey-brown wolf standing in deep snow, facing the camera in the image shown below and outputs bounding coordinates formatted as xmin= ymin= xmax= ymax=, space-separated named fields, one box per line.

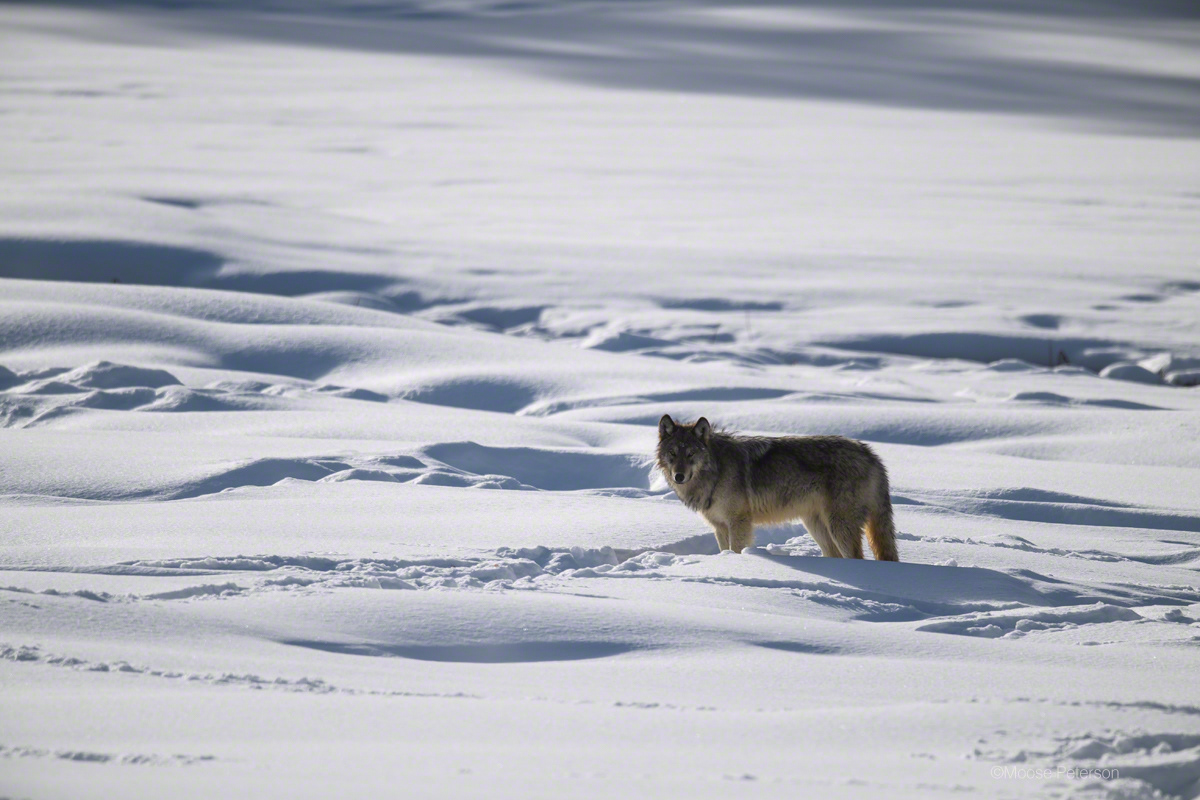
xmin=658 ymin=414 xmax=900 ymax=561
